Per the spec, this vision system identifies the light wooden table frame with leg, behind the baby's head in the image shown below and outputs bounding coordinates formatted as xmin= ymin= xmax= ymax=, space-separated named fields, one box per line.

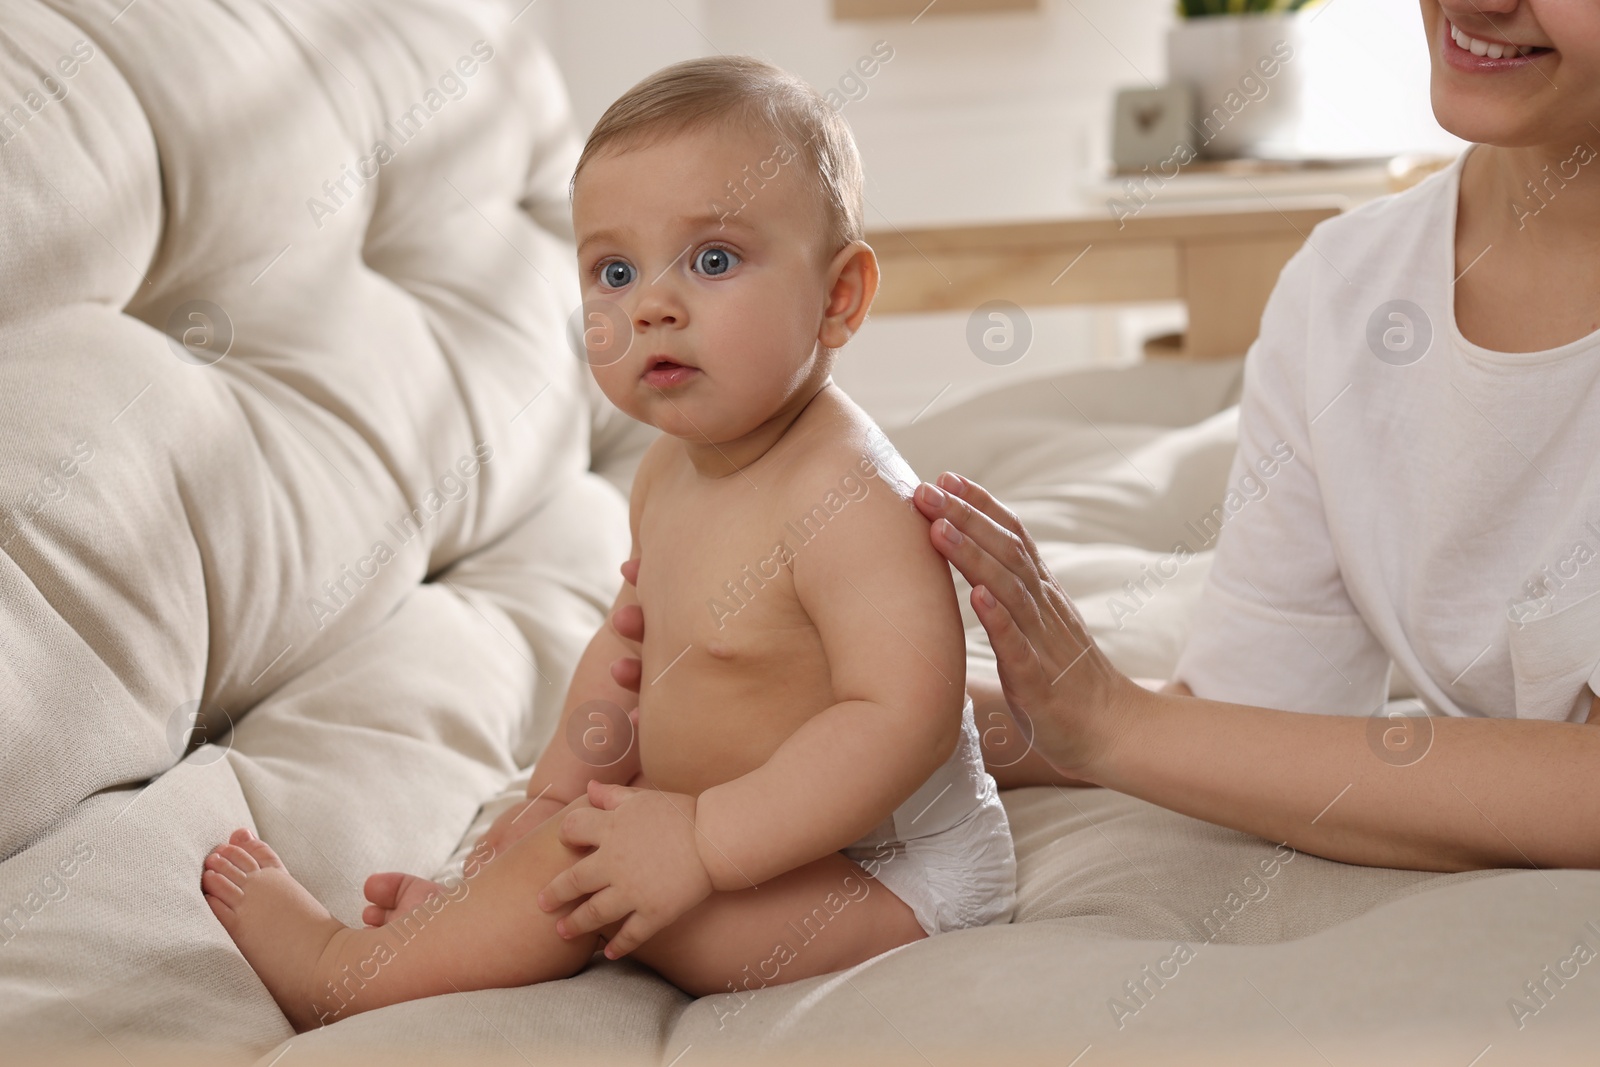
xmin=867 ymin=198 xmax=1342 ymax=358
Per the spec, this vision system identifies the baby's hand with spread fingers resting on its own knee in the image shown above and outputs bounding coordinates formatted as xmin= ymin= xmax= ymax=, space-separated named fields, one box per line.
xmin=538 ymin=782 xmax=712 ymax=960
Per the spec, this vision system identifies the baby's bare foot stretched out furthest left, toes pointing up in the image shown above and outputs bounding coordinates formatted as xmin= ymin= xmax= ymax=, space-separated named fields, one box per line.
xmin=200 ymin=830 xmax=354 ymax=1030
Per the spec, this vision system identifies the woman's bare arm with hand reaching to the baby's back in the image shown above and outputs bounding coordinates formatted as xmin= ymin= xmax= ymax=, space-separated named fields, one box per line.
xmin=917 ymin=475 xmax=1600 ymax=870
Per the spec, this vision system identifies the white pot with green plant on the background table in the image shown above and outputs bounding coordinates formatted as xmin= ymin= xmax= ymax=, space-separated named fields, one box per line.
xmin=1166 ymin=0 xmax=1317 ymax=158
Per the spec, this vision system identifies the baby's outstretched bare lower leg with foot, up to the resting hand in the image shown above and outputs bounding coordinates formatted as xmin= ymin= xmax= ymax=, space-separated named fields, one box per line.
xmin=202 ymin=797 xmax=598 ymax=1030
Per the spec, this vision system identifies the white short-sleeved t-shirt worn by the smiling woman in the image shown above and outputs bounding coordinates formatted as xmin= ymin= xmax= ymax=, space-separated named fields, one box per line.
xmin=1174 ymin=146 xmax=1600 ymax=720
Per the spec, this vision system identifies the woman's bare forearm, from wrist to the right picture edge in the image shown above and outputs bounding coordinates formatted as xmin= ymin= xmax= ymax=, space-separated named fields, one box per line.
xmin=1086 ymin=686 xmax=1600 ymax=870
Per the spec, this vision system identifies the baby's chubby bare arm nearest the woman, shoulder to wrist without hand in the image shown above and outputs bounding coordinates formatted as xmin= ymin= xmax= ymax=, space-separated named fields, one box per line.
xmin=694 ymin=480 xmax=966 ymax=889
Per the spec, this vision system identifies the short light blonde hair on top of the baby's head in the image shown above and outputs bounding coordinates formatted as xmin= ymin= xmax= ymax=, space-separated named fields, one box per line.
xmin=573 ymin=56 xmax=864 ymax=253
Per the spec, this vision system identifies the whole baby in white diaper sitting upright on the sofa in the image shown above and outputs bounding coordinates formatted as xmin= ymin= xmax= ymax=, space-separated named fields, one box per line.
xmin=202 ymin=58 xmax=1016 ymax=1030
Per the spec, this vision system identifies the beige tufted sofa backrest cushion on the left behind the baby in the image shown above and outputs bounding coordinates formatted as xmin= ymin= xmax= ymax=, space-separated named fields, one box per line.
xmin=0 ymin=0 xmax=627 ymax=1043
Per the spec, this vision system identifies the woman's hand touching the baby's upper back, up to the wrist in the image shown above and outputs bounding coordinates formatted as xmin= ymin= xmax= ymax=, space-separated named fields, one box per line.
xmin=915 ymin=474 xmax=1142 ymax=781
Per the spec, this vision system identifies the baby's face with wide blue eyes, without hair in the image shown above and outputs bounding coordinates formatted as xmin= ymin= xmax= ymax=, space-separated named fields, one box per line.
xmin=573 ymin=125 xmax=838 ymax=443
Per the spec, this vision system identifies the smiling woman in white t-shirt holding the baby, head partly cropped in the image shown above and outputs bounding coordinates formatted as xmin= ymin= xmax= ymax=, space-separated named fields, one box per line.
xmin=614 ymin=0 xmax=1600 ymax=870
